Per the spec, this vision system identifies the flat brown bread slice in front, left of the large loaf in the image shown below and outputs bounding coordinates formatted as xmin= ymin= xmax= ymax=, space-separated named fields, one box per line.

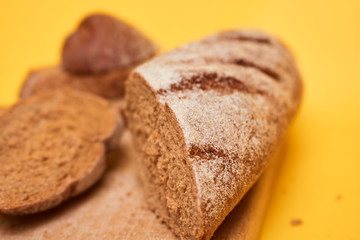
xmin=0 ymin=89 xmax=121 ymax=214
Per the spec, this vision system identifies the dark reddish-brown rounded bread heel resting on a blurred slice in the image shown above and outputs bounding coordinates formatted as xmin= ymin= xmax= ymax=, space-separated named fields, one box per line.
xmin=62 ymin=14 xmax=157 ymax=73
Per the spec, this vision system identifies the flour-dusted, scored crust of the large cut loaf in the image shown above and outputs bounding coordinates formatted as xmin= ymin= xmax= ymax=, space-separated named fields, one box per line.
xmin=128 ymin=30 xmax=302 ymax=239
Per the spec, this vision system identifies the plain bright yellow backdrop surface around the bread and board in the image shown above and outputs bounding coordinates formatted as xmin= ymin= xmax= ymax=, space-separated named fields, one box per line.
xmin=0 ymin=0 xmax=360 ymax=240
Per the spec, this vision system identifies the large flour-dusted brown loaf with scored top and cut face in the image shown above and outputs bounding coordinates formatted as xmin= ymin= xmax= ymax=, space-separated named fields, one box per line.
xmin=125 ymin=31 xmax=302 ymax=239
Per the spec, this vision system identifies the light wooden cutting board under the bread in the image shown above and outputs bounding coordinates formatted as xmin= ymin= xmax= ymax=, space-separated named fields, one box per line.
xmin=0 ymin=133 xmax=279 ymax=240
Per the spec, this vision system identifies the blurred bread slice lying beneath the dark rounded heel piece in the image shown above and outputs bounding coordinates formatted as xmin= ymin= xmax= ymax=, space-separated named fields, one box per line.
xmin=20 ymin=67 xmax=131 ymax=99
